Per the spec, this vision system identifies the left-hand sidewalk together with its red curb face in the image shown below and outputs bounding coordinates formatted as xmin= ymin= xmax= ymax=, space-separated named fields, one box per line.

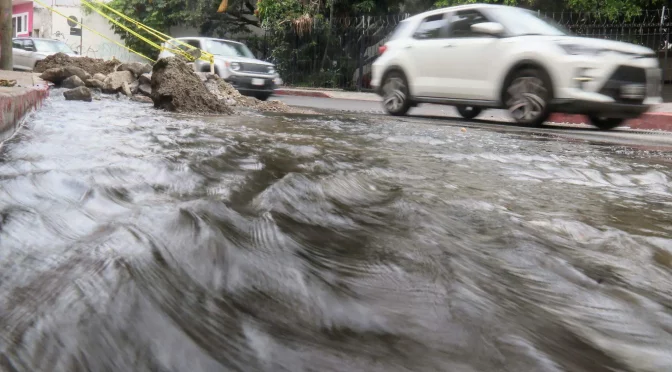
xmin=0 ymin=71 xmax=49 ymax=144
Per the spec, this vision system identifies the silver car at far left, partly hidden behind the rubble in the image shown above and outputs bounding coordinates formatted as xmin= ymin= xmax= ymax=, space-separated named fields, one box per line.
xmin=12 ymin=38 xmax=77 ymax=71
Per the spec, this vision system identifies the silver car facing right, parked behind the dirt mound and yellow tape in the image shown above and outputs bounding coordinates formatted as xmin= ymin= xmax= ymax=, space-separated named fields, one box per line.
xmin=159 ymin=37 xmax=282 ymax=100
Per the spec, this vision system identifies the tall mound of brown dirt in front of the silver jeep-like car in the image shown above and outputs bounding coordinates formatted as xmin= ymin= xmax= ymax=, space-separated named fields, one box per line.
xmin=151 ymin=57 xmax=232 ymax=114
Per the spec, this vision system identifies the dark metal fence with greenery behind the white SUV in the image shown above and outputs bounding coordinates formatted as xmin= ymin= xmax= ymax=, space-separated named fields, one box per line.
xmin=228 ymin=8 xmax=672 ymax=90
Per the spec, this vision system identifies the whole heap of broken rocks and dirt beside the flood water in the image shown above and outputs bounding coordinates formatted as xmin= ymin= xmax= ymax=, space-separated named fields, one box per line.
xmin=35 ymin=53 xmax=312 ymax=114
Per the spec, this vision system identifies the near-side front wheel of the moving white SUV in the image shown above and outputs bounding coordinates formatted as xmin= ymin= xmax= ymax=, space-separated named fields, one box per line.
xmin=503 ymin=68 xmax=553 ymax=126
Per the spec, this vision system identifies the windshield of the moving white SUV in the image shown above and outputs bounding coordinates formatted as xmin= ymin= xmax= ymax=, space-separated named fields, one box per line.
xmin=491 ymin=7 xmax=569 ymax=36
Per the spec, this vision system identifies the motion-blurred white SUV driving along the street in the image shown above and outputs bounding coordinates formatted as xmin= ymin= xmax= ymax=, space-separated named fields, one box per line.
xmin=371 ymin=4 xmax=662 ymax=129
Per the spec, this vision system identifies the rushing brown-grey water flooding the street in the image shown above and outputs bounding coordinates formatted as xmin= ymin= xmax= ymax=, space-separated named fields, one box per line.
xmin=0 ymin=92 xmax=672 ymax=372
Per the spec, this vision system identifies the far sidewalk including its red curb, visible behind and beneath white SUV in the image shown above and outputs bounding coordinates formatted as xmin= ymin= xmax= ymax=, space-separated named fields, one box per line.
xmin=275 ymin=88 xmax=672 ymax=132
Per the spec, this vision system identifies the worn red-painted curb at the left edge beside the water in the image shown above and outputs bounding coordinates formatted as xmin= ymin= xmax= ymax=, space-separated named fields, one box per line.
xmin=0 ymin=85 xmax=49 ymax=145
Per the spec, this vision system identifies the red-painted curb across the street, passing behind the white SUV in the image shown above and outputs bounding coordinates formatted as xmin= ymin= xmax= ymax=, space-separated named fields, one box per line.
xmin=274 ymin=89 xmax=672 ymax=132
